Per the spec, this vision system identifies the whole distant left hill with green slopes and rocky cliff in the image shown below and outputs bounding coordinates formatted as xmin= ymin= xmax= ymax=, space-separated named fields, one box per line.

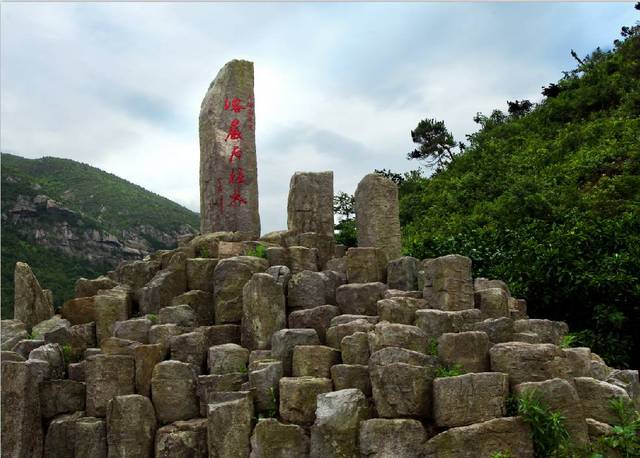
xmin=1 ymin=154 xmax=199 ymax=318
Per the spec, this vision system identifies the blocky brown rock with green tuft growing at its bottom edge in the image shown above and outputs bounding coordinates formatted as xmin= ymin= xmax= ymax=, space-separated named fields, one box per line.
xmin=438 ymin=331 xmax=490 ymax=372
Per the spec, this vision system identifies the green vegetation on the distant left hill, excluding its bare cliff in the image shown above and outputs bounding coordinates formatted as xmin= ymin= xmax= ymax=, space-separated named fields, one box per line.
xmin=1 ymin=154 xmax=199 ymax=318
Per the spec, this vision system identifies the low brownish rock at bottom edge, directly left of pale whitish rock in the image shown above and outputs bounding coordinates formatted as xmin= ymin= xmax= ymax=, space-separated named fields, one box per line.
xmin=249 ymin=418 xmax=309 ymax=458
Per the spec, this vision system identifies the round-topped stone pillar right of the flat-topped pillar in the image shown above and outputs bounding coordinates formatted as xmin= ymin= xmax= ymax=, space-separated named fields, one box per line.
xmin=355 ymin=173 xmax=402 ymax=261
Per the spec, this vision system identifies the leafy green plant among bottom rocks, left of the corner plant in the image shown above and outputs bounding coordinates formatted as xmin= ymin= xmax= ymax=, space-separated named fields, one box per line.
xmin=518 ymin=390 xmax=571 ymax=458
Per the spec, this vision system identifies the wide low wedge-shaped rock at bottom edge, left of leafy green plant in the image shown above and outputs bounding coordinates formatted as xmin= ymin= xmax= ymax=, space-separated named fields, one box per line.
xmin=421 ymin=417 xmax=534 ymax=458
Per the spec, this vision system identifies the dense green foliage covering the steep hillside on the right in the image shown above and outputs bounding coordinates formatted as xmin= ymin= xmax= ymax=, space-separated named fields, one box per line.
xmin=400 ymin=26 xmax=640 ymax=367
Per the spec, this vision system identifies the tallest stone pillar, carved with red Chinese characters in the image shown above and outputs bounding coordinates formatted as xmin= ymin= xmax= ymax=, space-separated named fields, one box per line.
xmin=200 ymin=60 xmax=260 ymax=239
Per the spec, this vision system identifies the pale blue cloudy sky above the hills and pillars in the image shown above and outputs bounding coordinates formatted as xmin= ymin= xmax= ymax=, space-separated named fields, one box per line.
xmin=0 ymin=2 xmax=637 ymax=233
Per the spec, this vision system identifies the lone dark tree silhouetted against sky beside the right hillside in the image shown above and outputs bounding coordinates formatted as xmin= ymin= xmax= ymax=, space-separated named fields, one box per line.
xmin=407 ymin=119 xmax=461 ymax=170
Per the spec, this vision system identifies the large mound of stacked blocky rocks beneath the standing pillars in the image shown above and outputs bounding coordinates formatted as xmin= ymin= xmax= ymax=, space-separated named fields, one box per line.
xmin=2 ymin=224 xmax=640 ymax=457
